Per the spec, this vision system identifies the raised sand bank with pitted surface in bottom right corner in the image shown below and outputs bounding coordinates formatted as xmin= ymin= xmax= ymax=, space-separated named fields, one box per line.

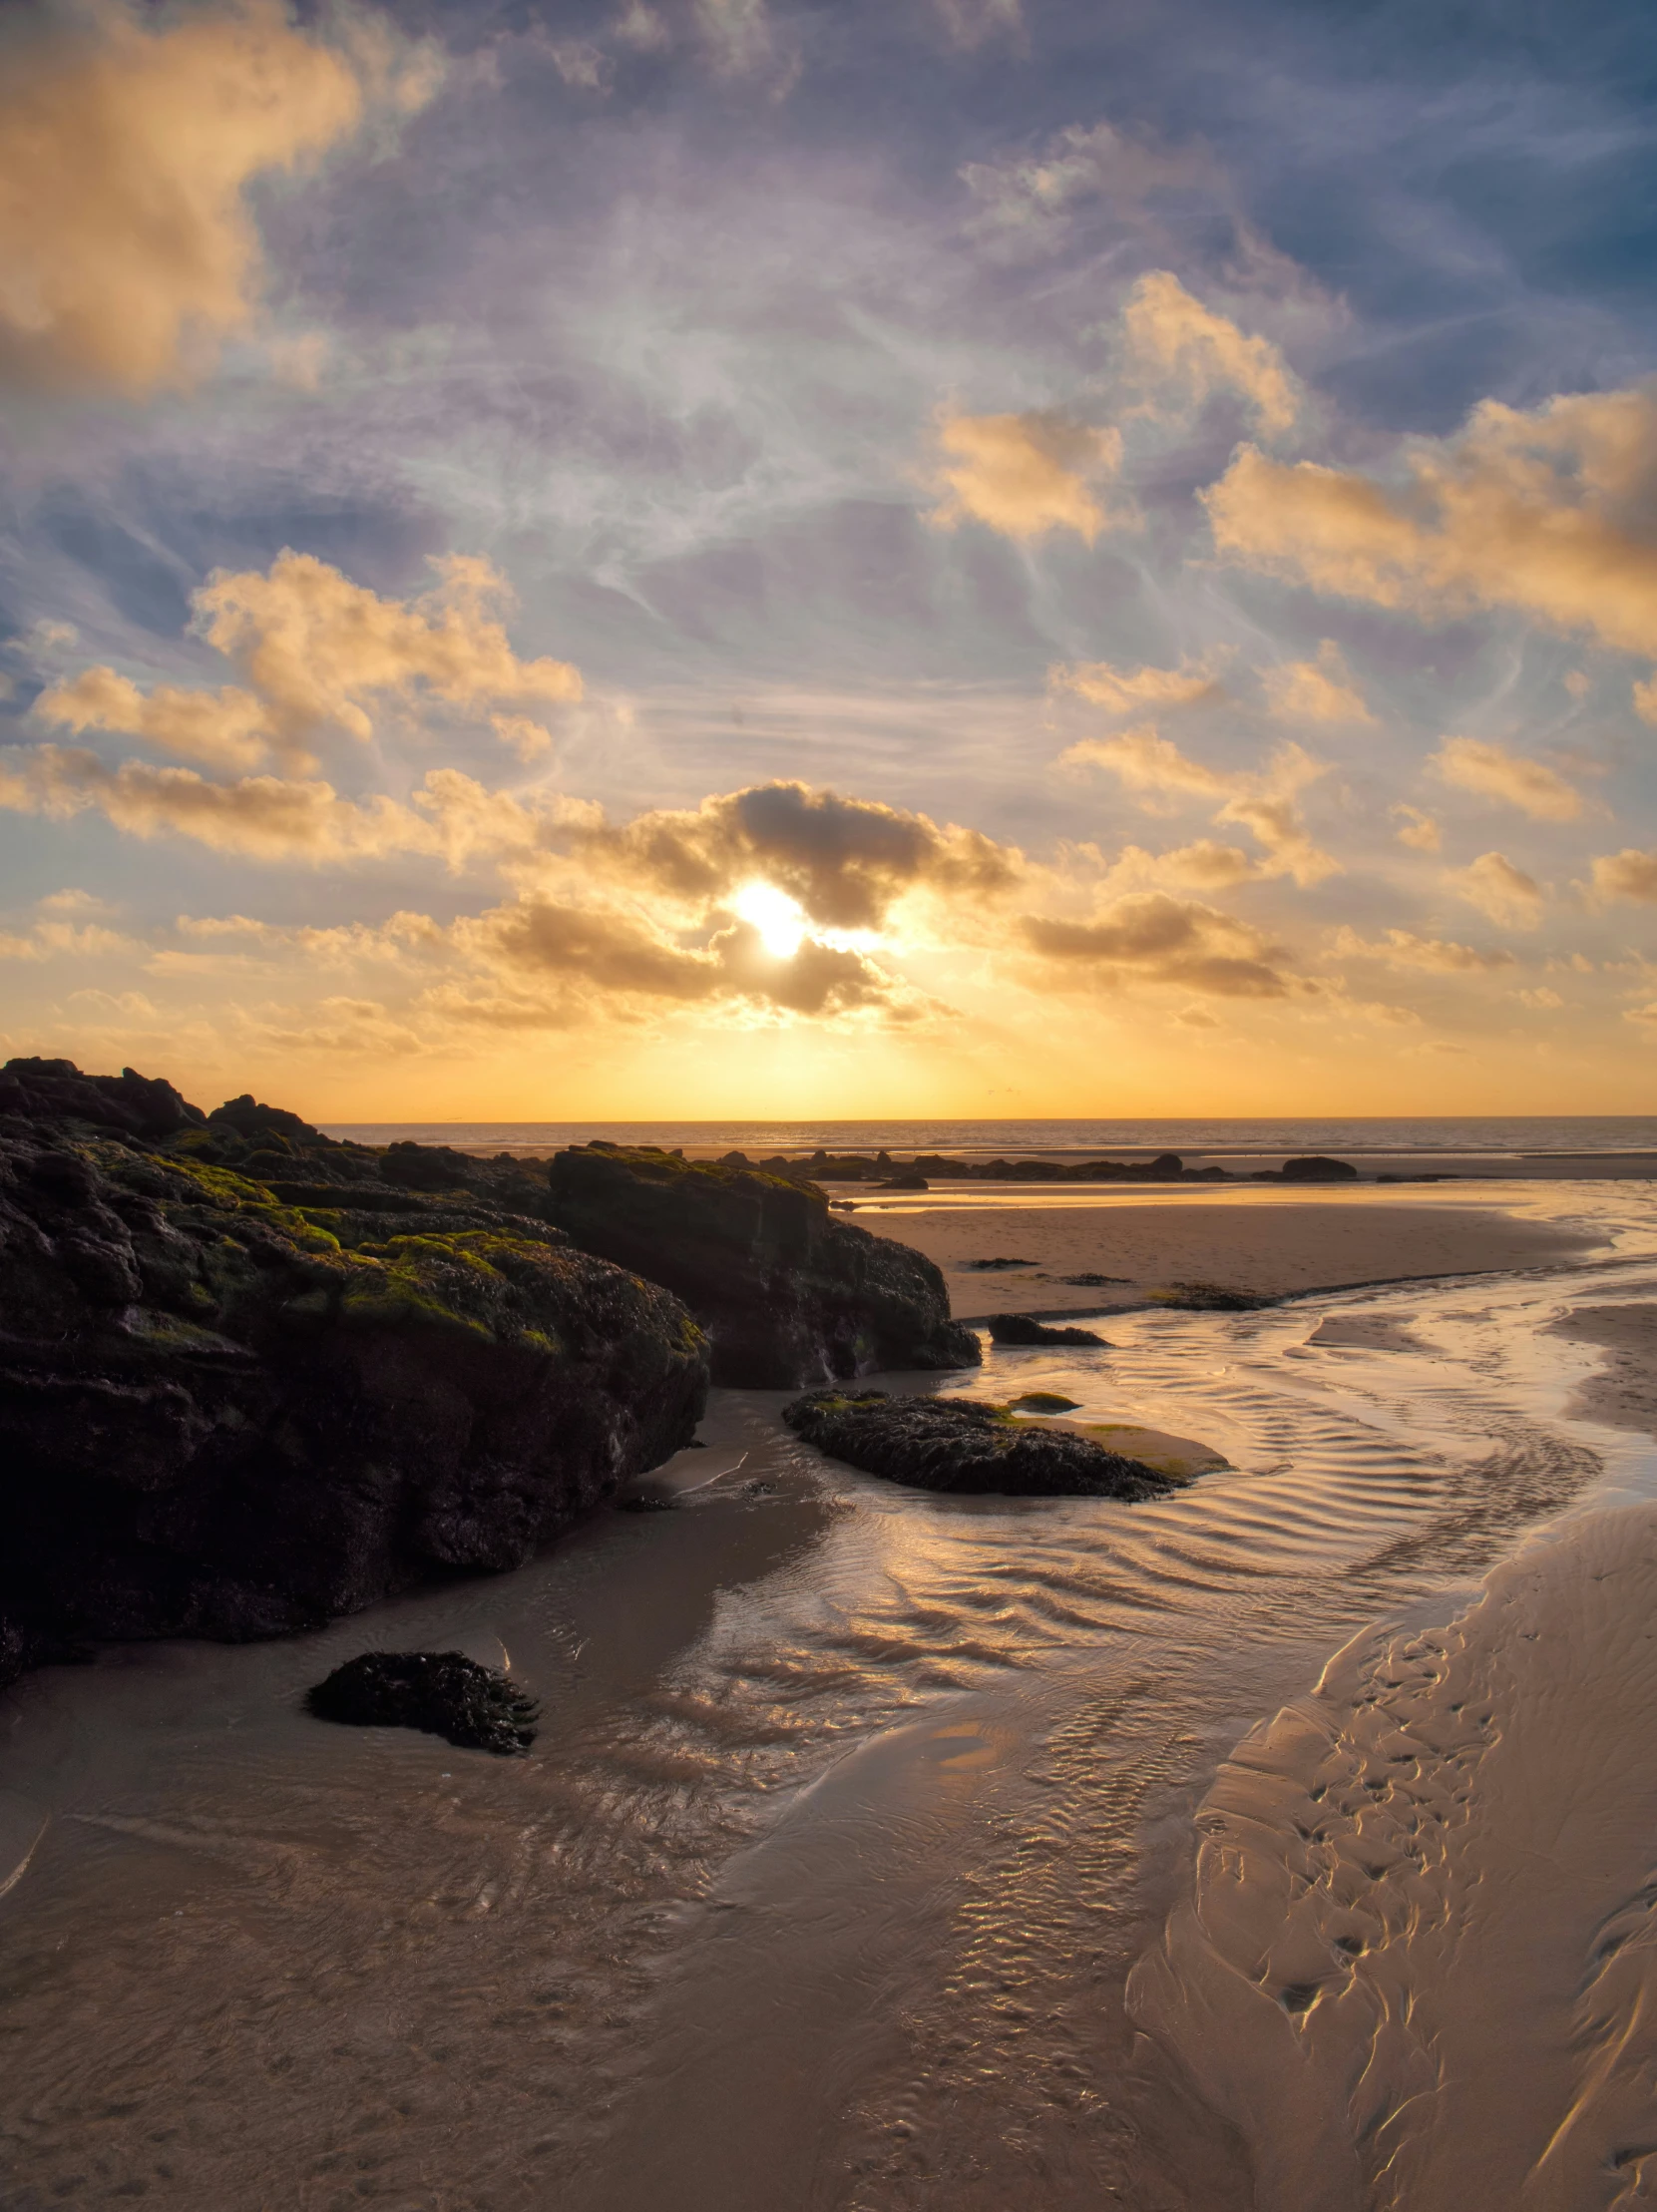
xmin=1128 ymin=1507 xmax=1657 ymax=2212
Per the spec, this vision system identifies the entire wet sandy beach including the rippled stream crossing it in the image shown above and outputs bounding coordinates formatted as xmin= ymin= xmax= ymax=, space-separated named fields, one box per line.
xmin=0 ymin=1181 xmax=1657 ymax=2212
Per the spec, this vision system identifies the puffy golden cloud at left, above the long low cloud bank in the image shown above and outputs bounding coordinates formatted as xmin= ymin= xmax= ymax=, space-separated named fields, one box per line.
xmin=33 ymin=551 xmax=582 ymax=767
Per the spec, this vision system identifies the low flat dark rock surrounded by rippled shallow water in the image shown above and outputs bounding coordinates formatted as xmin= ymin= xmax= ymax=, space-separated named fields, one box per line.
xmin=783 ymin=1389 xmax=1179 ymax=1502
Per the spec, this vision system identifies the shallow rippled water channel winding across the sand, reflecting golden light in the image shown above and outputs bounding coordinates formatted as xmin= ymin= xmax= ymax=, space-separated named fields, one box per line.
xmin=0 ymin=1185 xmax=1657 ymax=2212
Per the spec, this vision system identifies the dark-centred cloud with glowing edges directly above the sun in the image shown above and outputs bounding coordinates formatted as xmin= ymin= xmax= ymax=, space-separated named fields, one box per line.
xmin=571 ymin=783 xmax=1027 ymax=931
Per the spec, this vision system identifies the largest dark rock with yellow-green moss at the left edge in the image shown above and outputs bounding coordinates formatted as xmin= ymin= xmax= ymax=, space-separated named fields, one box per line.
xmin=0 ymin=1084 xmax=708 ymax=1672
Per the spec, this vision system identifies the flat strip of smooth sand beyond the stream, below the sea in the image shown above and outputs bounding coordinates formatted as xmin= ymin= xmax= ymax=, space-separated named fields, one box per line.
xmin=856 ymin=1190 xmax=1604 ymax=1318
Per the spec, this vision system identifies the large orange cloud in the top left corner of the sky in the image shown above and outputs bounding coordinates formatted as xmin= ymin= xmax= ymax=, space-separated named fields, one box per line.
xmin=0 ymin=0 xmax=436 ymax=396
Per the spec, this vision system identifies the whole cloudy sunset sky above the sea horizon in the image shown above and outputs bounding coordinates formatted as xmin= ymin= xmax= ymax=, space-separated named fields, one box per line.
xmin=0 ymin=0 xmax=1657 ymax=1121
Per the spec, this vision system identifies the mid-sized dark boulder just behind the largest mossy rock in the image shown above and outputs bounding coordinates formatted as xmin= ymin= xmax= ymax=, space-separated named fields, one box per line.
xmin=547 ymin=1143 xmax=980 ymax=1389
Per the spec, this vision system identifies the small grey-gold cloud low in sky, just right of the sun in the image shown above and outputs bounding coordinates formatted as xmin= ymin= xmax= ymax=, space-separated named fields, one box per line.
xmin=1018 ymin=891 xmax=1292 ymax=998
